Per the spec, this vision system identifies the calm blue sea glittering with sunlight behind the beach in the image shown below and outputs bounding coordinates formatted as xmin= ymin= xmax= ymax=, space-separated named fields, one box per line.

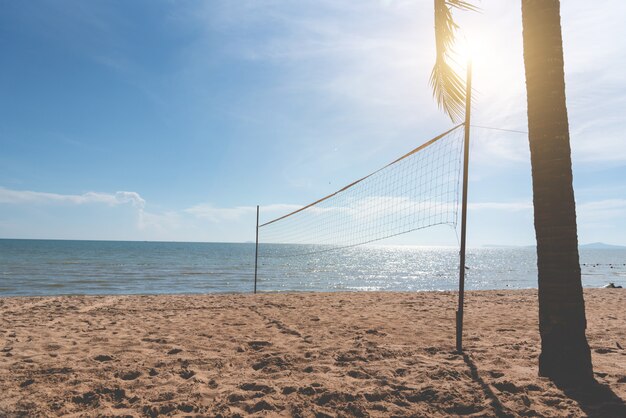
xmin=0 ymin=239 xmax=626 ymax=296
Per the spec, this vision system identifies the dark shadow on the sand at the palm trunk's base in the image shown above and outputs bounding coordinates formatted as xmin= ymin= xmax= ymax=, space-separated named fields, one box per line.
xmin=555 ymin=379 xmax=626 ymax=418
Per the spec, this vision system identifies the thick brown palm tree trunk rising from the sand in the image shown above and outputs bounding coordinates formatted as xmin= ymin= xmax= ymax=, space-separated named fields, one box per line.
xmin=522 ymin=0 xmax=593 ymax=383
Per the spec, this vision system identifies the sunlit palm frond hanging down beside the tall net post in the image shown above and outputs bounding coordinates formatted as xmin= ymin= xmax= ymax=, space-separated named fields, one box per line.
xmin=430 ymin=0 xmax=479 ymax=123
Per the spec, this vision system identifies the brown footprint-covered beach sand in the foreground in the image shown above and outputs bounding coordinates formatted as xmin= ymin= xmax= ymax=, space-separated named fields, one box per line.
xmin=0 ymin=289 xmax=626 ymax=417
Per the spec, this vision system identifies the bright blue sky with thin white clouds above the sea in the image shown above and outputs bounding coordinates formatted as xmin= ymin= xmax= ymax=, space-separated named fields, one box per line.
xmin=0 ymin=0 xmax=626 ymax=246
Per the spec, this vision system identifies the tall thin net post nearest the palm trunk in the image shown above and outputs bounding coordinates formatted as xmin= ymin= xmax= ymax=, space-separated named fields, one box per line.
xmin=456 ymin=60 xmax=472 ymax=353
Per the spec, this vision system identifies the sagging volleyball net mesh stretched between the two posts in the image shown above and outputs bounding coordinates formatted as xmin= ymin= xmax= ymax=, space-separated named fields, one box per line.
xmin=259 ymin=125 xmax=463 ymax=257
